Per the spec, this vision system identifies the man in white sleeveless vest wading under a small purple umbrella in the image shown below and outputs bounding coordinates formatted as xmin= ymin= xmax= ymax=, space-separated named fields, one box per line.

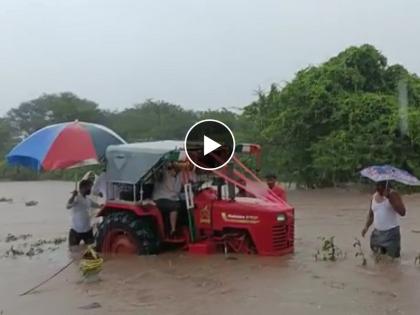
xmin=362 ymin=182 xmax=406 ymax=258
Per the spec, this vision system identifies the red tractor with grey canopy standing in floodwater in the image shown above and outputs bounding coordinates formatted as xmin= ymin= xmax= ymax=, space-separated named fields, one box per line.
xmin=96 ymin=141 xmax=294 ymax=256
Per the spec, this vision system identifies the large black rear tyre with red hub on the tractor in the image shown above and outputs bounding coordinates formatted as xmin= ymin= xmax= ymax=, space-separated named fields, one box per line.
xmin=96 ymin=212 xmax=160 ymax=255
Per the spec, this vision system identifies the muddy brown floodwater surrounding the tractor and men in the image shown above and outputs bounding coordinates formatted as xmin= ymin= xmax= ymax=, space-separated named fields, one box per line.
xmin=0 ymin=182 xmax=420 ymax=315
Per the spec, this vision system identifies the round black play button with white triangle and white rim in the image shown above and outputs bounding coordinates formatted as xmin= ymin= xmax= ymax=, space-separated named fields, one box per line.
xmin=184 ymin=119 xmax=235 ymax=170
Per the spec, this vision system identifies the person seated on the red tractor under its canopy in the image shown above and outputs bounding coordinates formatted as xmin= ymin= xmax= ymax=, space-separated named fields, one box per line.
xmin=153 ymin=163 xmax=182 ymax=238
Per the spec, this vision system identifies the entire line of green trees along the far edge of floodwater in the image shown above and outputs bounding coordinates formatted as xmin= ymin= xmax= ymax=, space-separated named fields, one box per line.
xmin=0 ymin=45 xmax=420 ymax=187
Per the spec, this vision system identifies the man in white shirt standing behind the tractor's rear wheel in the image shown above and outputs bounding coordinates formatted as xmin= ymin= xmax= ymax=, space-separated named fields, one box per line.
xmin=67 ymin=180 xmax=100 ymax=247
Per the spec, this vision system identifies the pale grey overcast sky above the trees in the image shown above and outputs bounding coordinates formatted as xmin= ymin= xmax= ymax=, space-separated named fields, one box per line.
xmin=0 ymin=0 xmax=420 ymax=114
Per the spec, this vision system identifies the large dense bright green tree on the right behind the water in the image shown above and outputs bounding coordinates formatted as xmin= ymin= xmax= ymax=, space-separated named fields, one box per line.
xmin=244 ymin=45 xmax=420 ymax=186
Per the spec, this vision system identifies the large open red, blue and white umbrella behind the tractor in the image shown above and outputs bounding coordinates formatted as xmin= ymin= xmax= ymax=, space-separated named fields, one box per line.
xmin=6 ymin=121 xmax=125 ymax=171
